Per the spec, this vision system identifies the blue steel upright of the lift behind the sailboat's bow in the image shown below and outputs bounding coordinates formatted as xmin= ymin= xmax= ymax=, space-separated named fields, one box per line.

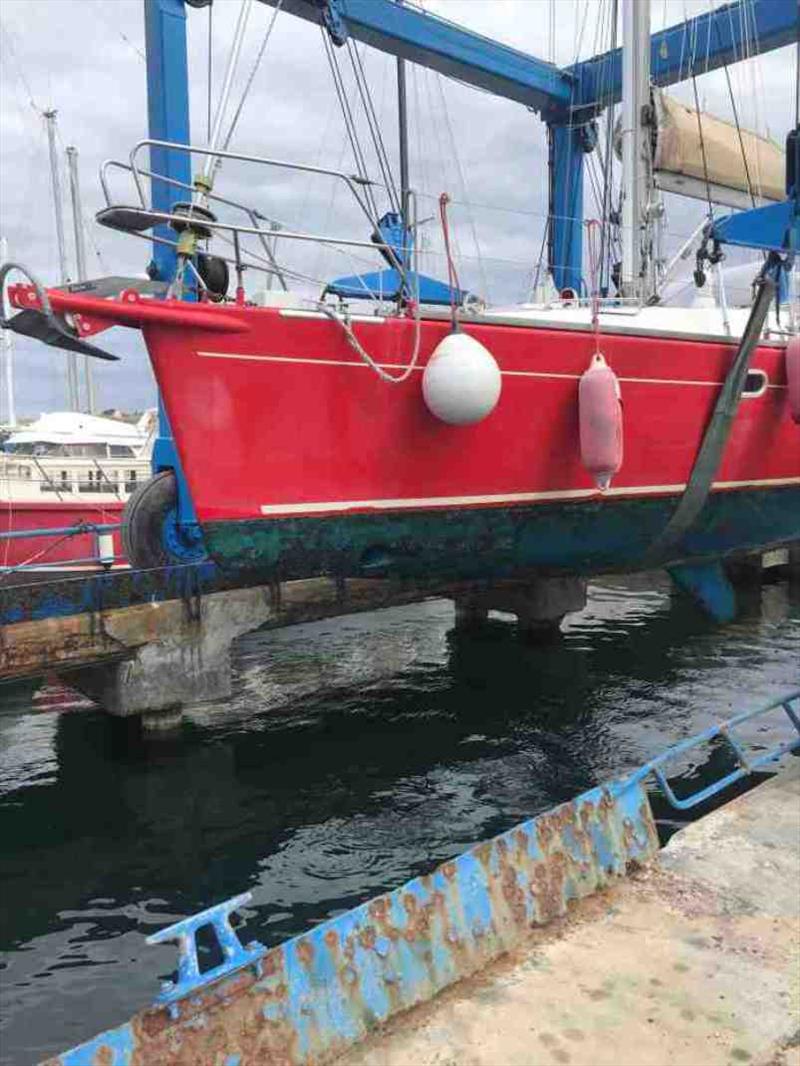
xmin=144 ymin=0 xmax=197 ymax=528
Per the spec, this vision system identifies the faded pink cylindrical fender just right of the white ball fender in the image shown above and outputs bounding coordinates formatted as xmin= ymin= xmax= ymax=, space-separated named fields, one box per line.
xmin=578 ymin=352 xmax=622 ymax=489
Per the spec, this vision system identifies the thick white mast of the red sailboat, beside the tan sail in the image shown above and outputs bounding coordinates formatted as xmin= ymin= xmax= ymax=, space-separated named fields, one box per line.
xmin=622 ymin=0 xmax=650 ymax=297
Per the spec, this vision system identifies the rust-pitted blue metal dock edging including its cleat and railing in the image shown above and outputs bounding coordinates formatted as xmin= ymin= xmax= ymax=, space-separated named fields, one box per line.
xmin=54 ymin=692 xmax=800 ymax=1066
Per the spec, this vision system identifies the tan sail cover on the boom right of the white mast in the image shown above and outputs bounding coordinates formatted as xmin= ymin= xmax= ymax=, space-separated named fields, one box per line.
xmin=653 ymin=88 xmax=786 ymax=207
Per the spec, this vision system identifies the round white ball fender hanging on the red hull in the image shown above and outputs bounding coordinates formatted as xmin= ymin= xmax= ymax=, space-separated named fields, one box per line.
xmin=422 ymin=333 xmax=502 ymax=425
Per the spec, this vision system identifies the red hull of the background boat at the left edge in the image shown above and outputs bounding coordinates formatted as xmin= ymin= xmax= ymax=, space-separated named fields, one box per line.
xmin=0 ymin=502 xmax=124 ymax=567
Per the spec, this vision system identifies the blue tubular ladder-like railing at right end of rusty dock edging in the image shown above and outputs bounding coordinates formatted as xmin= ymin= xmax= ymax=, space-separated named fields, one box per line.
xmin=634 ymin=689 xmax=800 ymax=810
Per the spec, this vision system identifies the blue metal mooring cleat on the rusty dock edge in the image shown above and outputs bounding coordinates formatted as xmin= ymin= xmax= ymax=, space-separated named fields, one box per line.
xmin=147 ymin=892 xmax=267 ymax=1017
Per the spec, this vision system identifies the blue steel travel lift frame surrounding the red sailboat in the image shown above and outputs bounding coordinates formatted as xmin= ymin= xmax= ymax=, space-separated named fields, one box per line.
xmin=144 ymin=0 xmax=800 ymax=601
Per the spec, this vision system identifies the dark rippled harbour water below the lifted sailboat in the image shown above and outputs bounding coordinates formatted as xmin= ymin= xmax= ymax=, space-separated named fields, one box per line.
xmin=0 ymin=582 xmax=800 ymax=1066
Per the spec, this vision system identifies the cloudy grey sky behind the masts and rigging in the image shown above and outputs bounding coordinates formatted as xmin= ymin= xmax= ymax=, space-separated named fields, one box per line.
xmin=0 ymin=0 xmax=797 ymax=421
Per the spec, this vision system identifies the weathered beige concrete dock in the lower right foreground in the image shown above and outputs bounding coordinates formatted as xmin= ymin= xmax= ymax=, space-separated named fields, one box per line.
xmin=337 ymin=758 xmax=800 ymax=1066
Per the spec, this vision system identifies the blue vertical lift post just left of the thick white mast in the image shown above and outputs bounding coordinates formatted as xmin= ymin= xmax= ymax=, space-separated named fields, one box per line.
xmin=547 ymin=125 xmax=585 ymax=294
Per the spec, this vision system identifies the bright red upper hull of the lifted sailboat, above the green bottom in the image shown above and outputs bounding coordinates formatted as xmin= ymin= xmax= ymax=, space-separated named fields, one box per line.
xmin=136 ymin=310 xmax=800 ymax=522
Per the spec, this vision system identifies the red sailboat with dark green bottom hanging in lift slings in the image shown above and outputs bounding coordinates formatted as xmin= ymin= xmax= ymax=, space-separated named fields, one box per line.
xmin=1 ymin=2 xmax=800 ymax=596
